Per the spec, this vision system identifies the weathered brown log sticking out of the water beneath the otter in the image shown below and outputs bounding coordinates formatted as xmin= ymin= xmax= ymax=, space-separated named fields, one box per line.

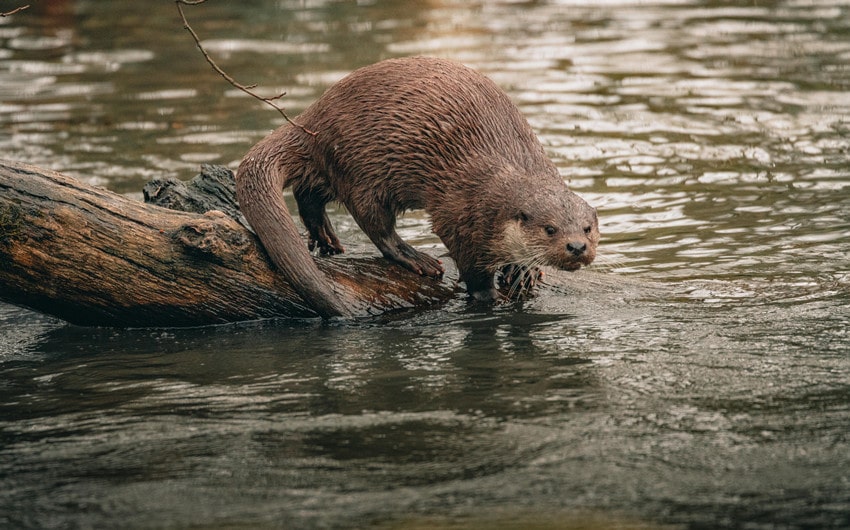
xmin=0 ymin=161 xmax=455 ymax=327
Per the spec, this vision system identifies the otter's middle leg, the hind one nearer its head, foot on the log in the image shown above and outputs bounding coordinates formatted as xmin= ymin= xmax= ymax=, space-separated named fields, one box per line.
xmin=349 ymin=205 xmax=445 ymax=278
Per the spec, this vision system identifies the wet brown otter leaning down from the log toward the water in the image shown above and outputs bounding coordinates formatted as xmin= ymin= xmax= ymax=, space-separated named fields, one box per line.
xmin=236 ymin=57 xmax=599 ymax=318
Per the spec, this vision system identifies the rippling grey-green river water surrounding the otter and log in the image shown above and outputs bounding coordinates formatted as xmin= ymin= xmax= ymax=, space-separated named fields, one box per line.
xmin=0 ymin=0 xmax=850 ymax=528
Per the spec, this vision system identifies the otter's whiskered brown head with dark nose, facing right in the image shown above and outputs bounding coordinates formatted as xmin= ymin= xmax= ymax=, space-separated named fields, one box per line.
xmin=496 ymin=185 xmax=599 ymax=270
